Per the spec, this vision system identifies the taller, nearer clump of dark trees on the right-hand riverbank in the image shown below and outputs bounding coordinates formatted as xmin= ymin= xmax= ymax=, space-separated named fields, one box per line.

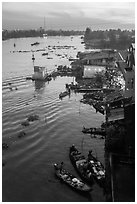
xmin=84 ymin=27 xmax=135 ymax=49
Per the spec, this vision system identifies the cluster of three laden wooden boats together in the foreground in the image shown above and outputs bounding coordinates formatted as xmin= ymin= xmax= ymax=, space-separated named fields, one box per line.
xmin=54 ymin=144 xmax=105 ymax=192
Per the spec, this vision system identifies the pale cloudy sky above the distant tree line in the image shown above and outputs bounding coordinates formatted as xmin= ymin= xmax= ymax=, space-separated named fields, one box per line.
xmin=2 ymin=1 xmax=135 ymax=30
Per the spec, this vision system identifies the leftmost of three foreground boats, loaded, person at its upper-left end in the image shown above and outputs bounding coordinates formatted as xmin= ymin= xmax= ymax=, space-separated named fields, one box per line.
xmin=54 ymin=164 xmax=92 ymax=192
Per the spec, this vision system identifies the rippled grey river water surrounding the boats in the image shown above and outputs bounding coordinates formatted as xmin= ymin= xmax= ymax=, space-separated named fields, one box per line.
xmin=2 ymin=36 xmax=105 ymax=202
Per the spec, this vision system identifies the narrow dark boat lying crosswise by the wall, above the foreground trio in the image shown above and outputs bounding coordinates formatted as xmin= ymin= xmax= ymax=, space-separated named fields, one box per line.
xmin=82 ymin=127 xmax=106 ymax=136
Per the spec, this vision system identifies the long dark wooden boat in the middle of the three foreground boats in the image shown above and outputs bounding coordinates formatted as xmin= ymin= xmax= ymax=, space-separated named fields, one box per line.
xmin=69 ymin=147 xmax=94 ymax=184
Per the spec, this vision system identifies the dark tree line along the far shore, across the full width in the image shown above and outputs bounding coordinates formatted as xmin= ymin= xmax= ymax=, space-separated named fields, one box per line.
xmin=2 ymin=27 xmax=135 ymax=50
